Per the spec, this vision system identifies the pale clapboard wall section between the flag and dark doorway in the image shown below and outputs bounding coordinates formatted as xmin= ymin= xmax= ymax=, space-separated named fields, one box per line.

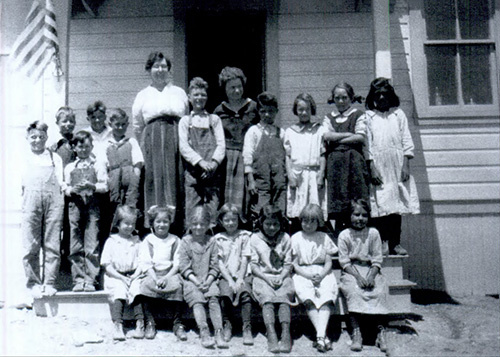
xmin=69 ymin=13 xmax=174 ymax=127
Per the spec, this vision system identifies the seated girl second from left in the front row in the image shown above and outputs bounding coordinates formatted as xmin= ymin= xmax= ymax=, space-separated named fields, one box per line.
xmin=139 ymin=206 xmax=187 ymax=341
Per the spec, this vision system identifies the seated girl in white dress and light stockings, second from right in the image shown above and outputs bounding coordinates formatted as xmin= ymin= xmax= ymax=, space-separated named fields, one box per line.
xmin=292 ymin=203 xmax=338 ymax=352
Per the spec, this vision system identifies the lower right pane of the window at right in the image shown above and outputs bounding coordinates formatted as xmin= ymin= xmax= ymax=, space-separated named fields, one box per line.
xmin=459 ymin=45 xmax=493 ymax=104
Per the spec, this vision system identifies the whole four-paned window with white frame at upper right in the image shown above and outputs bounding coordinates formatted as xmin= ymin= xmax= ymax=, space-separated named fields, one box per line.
xmin=410 ymin=0 xmax=499 ymax=117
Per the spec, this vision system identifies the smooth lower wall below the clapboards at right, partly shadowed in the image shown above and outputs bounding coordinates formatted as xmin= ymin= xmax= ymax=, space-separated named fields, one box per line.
xmin=403 ymin=215 xmax=500 ymax=296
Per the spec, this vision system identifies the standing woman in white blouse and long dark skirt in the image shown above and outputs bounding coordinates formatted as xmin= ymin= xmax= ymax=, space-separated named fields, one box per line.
xmin=132 ymin=52 xmax=189 ymax=235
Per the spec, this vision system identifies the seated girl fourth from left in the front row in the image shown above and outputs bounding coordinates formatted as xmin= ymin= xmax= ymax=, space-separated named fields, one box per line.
xmin=215 ymin=203 xmax=253 ymax=345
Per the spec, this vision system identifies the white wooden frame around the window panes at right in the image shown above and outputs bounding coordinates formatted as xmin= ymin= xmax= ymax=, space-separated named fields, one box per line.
xmin=410 ymin=0 xmax=500 ymax=118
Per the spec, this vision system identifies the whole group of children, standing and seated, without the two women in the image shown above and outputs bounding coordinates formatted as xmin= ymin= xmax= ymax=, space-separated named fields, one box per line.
xmin=23 ymin=73 xmax=418 ymax=353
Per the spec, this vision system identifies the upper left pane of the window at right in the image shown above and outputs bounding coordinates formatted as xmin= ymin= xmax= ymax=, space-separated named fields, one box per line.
xmin=425 ymin=0 xmax=457 ymax=40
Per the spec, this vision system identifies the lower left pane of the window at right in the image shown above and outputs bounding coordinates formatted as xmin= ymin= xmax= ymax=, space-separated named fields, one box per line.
xmin=425 ymin=45 xmax=458 ymax=105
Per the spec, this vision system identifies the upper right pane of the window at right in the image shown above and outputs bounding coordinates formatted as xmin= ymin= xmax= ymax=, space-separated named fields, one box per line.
xmin=458 ymin=0 xmax=490 ymax=39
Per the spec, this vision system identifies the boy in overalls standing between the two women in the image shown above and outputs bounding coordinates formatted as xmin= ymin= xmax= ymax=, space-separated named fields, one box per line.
xmin=179 ymin=77 xmax=226 ymax=224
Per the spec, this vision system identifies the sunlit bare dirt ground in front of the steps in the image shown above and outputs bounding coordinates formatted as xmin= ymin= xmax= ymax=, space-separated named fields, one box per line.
xmin=0 ymin=296 xmax=500 ymax=356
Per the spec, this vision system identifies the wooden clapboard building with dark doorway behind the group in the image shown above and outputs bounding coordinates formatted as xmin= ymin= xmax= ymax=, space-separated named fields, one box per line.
xmin=1 ymin=0 xmax=500 ymax=296
